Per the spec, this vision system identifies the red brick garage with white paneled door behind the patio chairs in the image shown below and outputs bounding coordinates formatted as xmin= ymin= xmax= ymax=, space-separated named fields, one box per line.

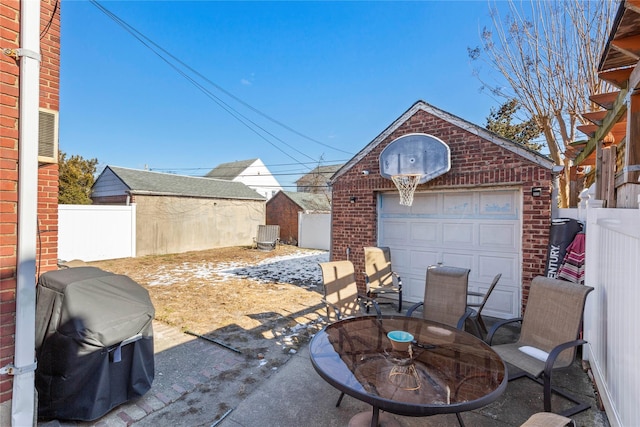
xmin=331 ymin=101 xmax=553 ymax=318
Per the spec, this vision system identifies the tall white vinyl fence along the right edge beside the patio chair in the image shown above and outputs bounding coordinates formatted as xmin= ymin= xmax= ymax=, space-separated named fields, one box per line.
xmin=584 ymin=208 xmax=640 ymax=427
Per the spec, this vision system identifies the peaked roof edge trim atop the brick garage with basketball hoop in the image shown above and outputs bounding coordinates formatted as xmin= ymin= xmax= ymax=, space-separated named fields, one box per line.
xmin=331 ymin=101 xmax=553 ymax=183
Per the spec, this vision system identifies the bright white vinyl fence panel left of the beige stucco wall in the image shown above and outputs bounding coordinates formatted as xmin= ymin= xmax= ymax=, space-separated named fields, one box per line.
xmin=58 ymin=204 xmax=136 ymax=261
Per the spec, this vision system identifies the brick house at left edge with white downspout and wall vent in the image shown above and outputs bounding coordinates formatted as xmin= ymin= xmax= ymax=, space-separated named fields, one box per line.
xmin=0 ymin=0 xmax=60 ymax=426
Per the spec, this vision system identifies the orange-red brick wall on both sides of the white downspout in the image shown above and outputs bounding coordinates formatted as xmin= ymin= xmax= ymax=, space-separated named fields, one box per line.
xmin=0 ymin=0 xmax=60 ymax=403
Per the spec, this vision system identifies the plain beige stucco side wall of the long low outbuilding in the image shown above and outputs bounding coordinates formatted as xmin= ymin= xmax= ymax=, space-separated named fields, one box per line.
xmin=133 ymin=195 xmax=265 ymax=256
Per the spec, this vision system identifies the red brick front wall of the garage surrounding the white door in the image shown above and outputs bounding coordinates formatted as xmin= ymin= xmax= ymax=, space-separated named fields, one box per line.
xmin=331 ymin=110 xmax=552 ymax=314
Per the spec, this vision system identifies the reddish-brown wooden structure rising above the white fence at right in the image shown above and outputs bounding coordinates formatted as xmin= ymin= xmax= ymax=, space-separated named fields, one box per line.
xmin=572 ymin=0 xmax=640 ymax=208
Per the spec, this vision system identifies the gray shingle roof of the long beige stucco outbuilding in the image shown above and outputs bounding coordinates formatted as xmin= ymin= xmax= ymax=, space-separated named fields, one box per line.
xmin=100 ymin=166 xmax=265 ymax=200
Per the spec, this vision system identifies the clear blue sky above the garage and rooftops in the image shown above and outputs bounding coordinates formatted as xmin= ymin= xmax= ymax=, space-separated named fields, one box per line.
xmin=60 ymin=1 xmax=498 ymax=190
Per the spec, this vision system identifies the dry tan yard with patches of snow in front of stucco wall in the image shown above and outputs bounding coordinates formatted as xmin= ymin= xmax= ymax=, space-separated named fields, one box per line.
xmin=89 ymin=245 xmax=328 ymax=365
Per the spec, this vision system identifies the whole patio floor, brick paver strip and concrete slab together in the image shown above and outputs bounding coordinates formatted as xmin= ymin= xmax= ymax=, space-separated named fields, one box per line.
xmin=38 ymin=306 xmax=610 ymax=427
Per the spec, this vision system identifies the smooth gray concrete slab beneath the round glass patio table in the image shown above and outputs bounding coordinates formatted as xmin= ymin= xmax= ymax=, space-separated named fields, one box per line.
xmin=216 ymin=313 xmax=609 ymax=427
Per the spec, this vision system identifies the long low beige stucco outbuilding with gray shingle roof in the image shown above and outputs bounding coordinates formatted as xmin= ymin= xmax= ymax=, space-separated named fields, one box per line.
xmin=91 ymin=166 xmax=265 ymax=256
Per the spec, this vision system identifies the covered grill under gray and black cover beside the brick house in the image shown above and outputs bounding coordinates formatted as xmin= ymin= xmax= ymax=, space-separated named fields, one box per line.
xmin=36 ymin=267 xmax=155 ymax=420
